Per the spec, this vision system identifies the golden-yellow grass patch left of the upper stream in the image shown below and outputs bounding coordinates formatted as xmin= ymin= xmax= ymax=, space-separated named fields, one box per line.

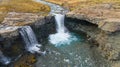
xmin=0 ymin=0 xmax=50 ymax=22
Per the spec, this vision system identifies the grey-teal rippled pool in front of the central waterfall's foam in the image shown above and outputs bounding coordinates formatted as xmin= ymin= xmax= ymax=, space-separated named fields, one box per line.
xmin=35 ymin=34 xmax=102 ymax=67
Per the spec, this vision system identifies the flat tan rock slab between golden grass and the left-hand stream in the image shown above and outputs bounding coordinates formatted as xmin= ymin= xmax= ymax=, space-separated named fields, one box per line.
xmin=2 ymin=12 xmax=44 ymax=26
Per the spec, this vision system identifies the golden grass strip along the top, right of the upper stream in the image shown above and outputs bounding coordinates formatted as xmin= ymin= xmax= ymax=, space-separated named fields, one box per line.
xmin=46 ymin=0 xmax=120 ymax=10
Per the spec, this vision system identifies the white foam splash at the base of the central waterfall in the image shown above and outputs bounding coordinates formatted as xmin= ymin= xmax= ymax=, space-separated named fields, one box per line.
xmin=49 ymin=33 xmax=77 ymax=47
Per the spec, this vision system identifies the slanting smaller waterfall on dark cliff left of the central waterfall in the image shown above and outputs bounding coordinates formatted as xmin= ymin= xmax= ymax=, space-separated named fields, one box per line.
xmin=20 ymin=26 xmax=41 ymax=53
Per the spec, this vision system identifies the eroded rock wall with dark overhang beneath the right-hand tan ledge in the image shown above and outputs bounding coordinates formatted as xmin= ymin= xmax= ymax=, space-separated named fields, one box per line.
xmin=66 ymin=15 xmax=120 ymax=66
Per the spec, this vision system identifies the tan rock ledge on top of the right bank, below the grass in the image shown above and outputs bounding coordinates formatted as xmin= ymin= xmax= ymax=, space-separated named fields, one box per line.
xmin=67 ymin=4 xmax=120 ymax=32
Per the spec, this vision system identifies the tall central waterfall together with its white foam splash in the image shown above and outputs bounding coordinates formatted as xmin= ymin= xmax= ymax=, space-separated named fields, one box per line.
xmin=49 ymin=14 xmax=77 ymax=46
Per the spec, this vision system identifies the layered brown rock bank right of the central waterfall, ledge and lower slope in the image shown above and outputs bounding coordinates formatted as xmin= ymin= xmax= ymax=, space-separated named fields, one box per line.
xmin=66 ymin=4 xmax=120 ymax=66
